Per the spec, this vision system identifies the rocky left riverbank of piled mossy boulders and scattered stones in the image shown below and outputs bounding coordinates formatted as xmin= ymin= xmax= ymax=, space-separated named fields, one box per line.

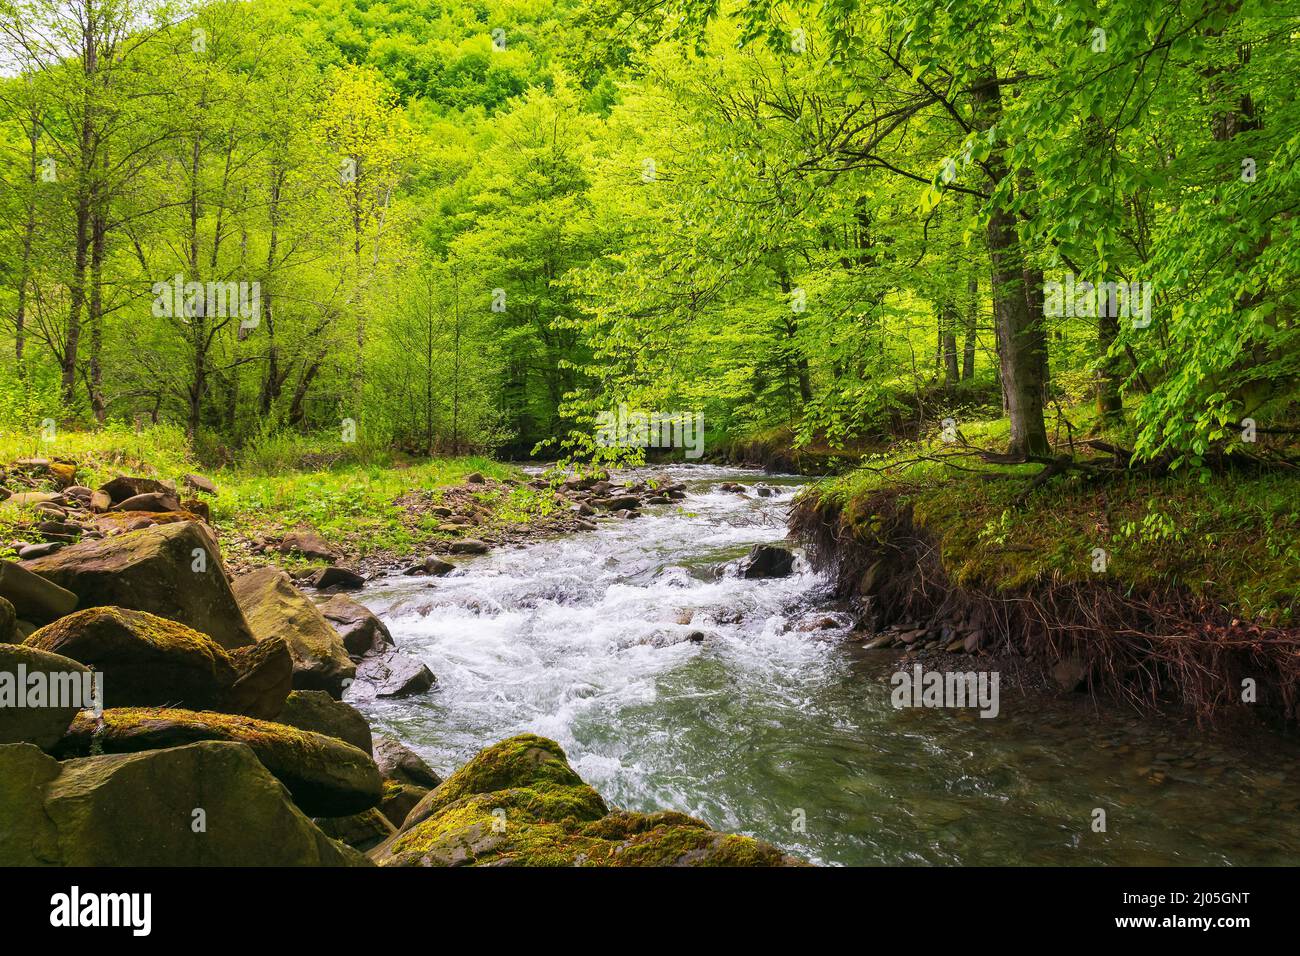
xmin=0 ymin=459 xmax=798 ymax=866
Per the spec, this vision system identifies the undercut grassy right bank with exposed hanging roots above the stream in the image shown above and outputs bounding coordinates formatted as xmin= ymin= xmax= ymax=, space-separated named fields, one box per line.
xmin=794 ymin=410 xmax=1300 ymax=717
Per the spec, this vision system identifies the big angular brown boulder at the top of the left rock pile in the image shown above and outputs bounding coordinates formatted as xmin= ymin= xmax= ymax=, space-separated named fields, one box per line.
xmin=20 ymin=522 xmax=254 ymax=650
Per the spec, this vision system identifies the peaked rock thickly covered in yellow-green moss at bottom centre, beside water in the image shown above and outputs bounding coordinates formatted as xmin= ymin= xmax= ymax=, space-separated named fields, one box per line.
xmin=371 ymin=734 xmax=800 ymax=866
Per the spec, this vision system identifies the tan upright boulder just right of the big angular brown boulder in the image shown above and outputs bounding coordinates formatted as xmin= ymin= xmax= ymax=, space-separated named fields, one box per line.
xmin=234 ymin=567 xmax=356 ymax=697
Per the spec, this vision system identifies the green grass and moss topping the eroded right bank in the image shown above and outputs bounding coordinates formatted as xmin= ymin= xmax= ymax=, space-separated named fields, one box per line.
xmin=816 ymin=410 xmax=1300 ymax=624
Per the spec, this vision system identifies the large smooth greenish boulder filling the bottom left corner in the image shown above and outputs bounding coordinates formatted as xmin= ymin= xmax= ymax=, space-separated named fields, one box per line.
xmin=0 ymin=741 xmax=367 ymax=866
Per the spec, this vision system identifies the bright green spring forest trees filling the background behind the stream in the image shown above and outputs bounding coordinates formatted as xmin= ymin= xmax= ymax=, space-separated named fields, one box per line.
xmin=0 ymin=0 xmax=1300 ymax=467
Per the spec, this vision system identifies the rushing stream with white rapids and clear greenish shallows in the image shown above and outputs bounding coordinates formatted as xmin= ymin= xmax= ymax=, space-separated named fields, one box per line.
xmin=363 ymin=466 xmax=1300 ymax=865
